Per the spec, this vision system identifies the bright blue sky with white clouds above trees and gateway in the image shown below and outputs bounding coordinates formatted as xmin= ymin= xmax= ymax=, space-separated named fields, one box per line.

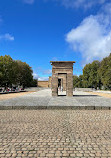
xmin=0 ymin=0 xmax=111 ymax=80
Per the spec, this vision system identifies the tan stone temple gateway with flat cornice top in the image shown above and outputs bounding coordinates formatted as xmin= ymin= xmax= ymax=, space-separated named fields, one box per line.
xmin=50 ymin=61 xmax=75 ymax=97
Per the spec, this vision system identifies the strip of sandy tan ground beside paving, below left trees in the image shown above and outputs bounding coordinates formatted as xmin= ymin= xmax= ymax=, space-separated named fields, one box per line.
xmin=0 ymin=92 xmax=32 ymax=100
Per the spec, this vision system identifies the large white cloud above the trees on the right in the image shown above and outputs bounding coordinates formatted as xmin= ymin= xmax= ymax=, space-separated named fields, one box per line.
xmin=66 ymin=3 xmax=111 ymax=64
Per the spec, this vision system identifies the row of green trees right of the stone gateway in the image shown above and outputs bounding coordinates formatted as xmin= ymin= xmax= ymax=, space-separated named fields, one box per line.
xmin=73 ymin=54 xmax=111 ymax=90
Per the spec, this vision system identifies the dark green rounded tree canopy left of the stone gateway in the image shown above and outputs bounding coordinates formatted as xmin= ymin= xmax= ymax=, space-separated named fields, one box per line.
xmin=0 ymin=55 xmax=36 ymax=87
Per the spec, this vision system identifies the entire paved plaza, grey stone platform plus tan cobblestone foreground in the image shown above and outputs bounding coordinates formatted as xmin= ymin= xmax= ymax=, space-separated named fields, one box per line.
xmin=0 ymin=89 xmax=111 ymax=158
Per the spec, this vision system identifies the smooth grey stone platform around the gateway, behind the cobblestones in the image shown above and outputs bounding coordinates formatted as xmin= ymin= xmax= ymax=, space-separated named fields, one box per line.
xmin=0 ymin=89 xmax=111 ymax=109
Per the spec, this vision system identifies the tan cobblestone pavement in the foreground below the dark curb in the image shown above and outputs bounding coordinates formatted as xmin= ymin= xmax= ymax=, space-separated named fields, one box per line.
xmin=0 ymin=110 xmax=111 ymax=158
